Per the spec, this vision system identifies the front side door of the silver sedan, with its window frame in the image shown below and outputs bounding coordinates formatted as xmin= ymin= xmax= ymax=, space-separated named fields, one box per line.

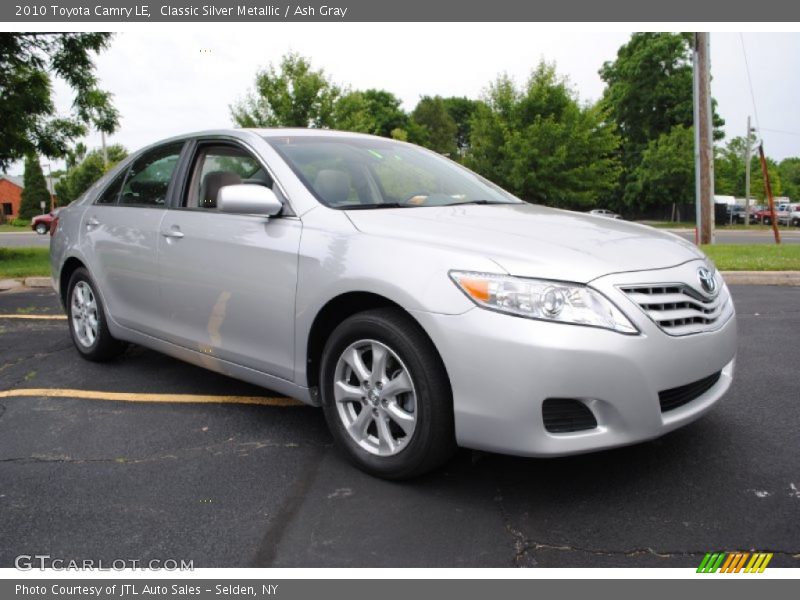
xmin=158 ymin=140 xmax=302 ymax=380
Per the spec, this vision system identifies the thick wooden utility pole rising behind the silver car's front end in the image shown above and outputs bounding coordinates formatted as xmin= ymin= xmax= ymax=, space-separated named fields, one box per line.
xmin=693 ymin=32 xmax=714 ymax=244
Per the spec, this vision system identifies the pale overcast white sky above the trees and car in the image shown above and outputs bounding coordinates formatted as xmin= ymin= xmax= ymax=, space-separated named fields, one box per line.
xmin=10 ymin=23 xmax=800 ymax=173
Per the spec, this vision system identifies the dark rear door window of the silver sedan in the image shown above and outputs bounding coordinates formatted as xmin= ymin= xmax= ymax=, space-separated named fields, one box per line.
xmin=119 ymin=143 xmax=183 ymax=206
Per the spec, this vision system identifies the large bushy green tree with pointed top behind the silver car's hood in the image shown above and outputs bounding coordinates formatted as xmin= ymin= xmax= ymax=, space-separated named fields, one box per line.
xmin=465 ymin=62 xmax=620 ymax=209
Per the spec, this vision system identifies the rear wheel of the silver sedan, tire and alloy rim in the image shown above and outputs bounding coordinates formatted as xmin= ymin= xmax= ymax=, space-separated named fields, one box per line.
xmin=67 ymin=267 xmax=125 ymax=362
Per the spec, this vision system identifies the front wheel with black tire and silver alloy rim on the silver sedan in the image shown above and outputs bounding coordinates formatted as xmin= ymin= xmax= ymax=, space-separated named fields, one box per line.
xmin=320 ymin=308 xmax=456 ymax=479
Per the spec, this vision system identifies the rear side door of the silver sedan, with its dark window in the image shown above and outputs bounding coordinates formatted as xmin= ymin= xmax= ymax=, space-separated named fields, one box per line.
xmin=82 ymin=142 xmax=183 ymax=334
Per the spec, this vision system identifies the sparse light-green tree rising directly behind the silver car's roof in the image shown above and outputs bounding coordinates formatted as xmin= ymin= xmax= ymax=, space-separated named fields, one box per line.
xmin=230 ymin=53 xmax=341 ymax=128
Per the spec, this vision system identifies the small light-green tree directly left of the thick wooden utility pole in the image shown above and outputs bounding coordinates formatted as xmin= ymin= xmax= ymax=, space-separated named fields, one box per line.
xmin=625 ymin=125 xmax=695 ymax=210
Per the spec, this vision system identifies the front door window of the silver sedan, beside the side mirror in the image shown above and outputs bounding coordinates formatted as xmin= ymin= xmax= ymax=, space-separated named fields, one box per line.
xmin=183 ymin=145 xmax=273 ymax=209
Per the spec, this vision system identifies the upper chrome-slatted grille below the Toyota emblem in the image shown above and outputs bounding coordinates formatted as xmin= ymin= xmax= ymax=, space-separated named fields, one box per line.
xmin=620 ymin=283 xmax=731 ymax=335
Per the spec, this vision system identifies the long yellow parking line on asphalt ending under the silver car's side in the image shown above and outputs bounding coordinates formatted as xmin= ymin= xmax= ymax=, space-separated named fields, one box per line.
xmin=0 ymin=388 xmax=303 ymax=407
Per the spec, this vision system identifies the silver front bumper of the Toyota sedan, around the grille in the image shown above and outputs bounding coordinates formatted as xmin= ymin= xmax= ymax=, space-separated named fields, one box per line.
xmin=414 ymin=263 xmax=737 ymax=456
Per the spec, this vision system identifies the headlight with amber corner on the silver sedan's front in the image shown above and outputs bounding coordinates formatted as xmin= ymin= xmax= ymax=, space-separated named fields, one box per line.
xmin=450 ymin=271 xmax=638 ymax=333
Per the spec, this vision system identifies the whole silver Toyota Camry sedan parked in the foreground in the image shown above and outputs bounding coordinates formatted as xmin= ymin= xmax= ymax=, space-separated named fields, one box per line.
xmin=51 ymin=129 xmax=736 ymax=479
